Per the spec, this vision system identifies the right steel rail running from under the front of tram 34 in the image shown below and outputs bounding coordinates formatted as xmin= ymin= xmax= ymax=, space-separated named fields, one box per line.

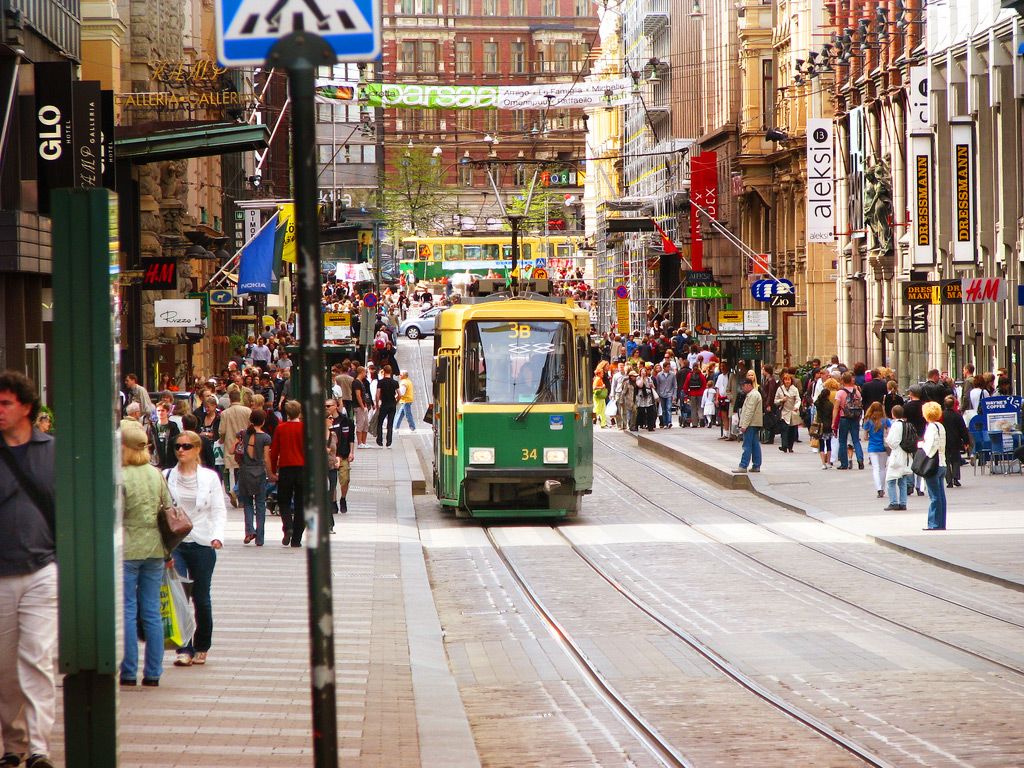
xmin=555 ymin=526 xmax=894 ymax=768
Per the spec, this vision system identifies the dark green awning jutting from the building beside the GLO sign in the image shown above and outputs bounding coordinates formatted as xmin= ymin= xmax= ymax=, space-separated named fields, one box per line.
xmin=114 ymin=123 xmax=270 ymax=163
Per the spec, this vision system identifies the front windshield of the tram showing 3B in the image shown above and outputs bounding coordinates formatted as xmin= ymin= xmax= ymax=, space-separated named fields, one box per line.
xmin=464 ymin=321 xmax=572 ymax=403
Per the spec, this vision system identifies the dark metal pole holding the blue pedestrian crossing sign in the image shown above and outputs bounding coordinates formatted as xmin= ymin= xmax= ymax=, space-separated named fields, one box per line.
xmin=267 ymin=32 xmax=338 ymax=768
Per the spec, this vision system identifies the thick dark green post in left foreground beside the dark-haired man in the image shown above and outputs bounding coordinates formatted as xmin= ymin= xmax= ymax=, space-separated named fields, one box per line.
xmin=53 ymin=189 xmax=120 ymax=768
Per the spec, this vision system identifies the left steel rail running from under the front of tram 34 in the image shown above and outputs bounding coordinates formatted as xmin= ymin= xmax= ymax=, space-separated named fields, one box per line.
xmin=483 ymin=527 xmax=693 ymax=768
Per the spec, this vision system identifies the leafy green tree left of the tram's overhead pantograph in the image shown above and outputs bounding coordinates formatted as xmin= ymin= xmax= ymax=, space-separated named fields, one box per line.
xmin=382 ymin=147 xmax=456 ymax=243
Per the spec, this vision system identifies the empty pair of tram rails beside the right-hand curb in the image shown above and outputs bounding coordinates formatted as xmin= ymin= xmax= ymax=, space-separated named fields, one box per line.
xmin=594 ymin=437 xmax=1024 ymax=677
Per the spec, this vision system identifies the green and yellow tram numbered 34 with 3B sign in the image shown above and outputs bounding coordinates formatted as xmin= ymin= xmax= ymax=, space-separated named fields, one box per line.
xmin=434 ymin=295 xmax=594 ymax=517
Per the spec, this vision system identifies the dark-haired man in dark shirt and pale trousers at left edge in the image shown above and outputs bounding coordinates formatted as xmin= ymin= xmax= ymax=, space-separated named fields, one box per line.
xmin=0 ymin=371 xmax=57 ymax=768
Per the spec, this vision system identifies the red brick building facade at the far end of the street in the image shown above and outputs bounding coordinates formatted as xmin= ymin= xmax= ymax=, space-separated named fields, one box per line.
xmin=382 ymin=0 xmax=598 ymax=229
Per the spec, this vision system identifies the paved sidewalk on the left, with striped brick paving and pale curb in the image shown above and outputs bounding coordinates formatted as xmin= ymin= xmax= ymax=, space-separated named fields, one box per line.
xmin=47 ymin=441 xmax=479 ymax=768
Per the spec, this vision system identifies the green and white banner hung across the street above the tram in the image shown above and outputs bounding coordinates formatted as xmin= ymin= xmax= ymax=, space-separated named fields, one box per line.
xmin=359 ymin=78 xmax=633 ymax=110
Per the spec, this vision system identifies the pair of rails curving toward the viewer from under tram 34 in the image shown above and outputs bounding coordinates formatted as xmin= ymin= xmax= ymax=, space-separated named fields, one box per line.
xmin=484 ymin=525 xmax=893 ymax=768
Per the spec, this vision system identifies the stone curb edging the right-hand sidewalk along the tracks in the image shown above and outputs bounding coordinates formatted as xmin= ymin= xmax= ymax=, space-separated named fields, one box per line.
xmin=636 ymin=435 xmax=1024 ymax=592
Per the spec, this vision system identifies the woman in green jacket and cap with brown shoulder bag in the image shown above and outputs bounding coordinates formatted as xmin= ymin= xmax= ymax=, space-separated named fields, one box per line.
xmin=121 ymin=424 xmax=170 ymax=686
